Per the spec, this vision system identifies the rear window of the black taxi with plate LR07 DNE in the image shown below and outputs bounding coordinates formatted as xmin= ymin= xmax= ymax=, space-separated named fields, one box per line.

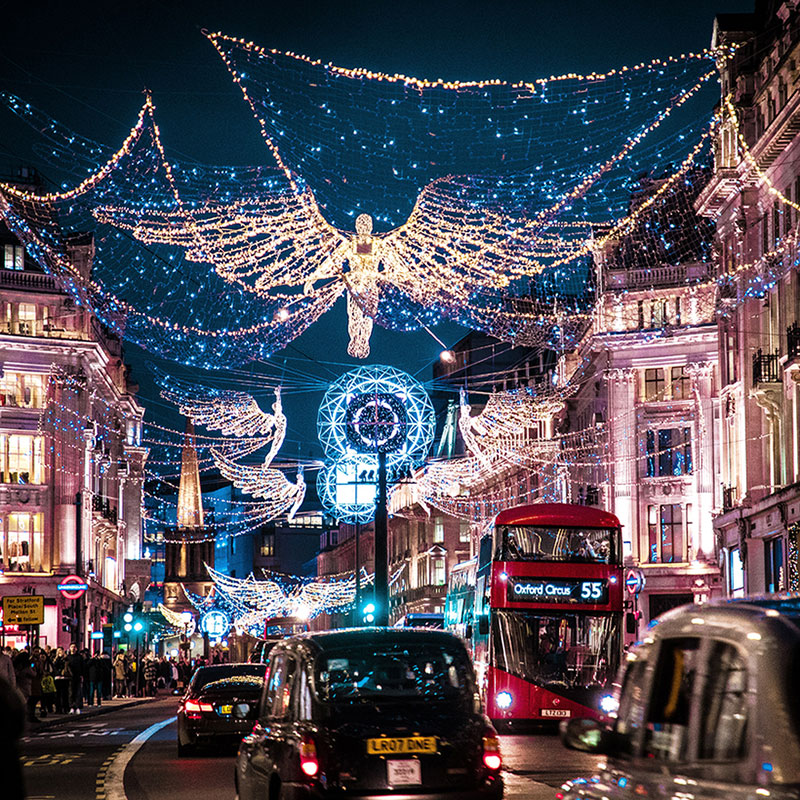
xmin=314 ymin=645 xmax=474 ymax=702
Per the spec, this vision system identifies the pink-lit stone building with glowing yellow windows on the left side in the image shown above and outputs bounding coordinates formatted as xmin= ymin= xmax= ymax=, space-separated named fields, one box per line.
xmin=0 ymin=173 xmax=147 ymax=645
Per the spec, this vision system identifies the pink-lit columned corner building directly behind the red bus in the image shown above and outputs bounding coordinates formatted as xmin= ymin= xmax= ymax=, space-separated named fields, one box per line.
xmin=558 ymin=212 xmax=722 ymax=634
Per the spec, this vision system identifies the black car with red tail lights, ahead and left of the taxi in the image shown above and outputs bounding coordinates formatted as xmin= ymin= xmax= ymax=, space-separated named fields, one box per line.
xmin=178 ymin=664 xmax=266 ymax=758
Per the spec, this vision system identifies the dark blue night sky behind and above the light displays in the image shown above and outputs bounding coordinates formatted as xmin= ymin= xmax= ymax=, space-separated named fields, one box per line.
xmin=0 ymin=0 xmax=753 ymax=458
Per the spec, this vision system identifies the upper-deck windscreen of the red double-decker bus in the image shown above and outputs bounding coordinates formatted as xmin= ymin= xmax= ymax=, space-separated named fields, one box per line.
xmin=495 ymin=525 xmax=619 ymax=564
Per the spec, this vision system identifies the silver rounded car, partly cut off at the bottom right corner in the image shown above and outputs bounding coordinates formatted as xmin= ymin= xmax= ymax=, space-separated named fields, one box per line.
xmin=557 ymin=595 xmax=800 ymax=800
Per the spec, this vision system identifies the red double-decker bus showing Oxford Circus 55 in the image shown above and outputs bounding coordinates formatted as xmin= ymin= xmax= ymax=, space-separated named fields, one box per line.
xmin=445 ymin=503 xmax=623 ymax=723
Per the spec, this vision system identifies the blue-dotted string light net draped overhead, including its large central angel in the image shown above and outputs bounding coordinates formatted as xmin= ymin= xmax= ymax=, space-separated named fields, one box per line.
xmin=0 ymin=34 xmax=724 ymax=366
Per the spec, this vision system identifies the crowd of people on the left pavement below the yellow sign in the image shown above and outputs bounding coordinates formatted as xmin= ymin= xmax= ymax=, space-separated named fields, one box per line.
xmin=0 ymin=644 xmax=193 ymax=722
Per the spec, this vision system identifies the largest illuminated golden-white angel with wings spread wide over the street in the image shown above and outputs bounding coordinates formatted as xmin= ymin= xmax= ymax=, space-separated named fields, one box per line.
xmin=89 ymin=154 xmax=549 ymax=358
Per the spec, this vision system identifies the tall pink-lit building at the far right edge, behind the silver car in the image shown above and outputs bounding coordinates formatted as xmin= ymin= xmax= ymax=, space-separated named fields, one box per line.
xmin=696 ymin=2 xmax=800 ymax=595
